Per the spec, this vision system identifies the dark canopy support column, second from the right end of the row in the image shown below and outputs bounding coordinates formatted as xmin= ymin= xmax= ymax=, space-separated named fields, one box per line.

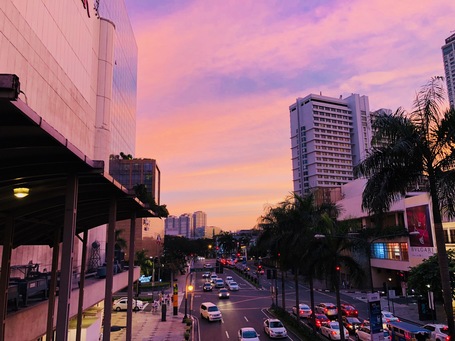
xmin=103 ymin=197 xmax=117 ymax=341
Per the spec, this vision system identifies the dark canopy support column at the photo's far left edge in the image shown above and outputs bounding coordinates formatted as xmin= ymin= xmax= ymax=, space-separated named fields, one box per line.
xmin=0 ymin=216 xmax=14 ymax=341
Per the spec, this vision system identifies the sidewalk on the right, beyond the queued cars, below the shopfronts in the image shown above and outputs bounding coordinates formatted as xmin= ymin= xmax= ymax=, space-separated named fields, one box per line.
xmin=341 ymin=290 xmax=447 ymax=325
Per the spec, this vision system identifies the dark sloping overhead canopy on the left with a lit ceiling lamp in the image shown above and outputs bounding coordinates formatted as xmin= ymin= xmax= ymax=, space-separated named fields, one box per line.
xmin=0 ymin=99 xmax=154 ymax=247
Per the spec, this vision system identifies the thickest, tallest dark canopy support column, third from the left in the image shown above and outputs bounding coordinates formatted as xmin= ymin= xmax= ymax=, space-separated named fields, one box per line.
xmin=56 ymin=175 xmax=79 ymax=341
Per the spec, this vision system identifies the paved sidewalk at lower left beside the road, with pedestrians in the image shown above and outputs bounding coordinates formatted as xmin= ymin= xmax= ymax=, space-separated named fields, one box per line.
xmin=110 ymin=275 xmax=190 ymax=341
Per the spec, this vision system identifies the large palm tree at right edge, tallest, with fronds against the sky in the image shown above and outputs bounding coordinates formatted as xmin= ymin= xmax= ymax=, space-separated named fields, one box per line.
xmin=355 ymin=77 xmax=455 ymax=338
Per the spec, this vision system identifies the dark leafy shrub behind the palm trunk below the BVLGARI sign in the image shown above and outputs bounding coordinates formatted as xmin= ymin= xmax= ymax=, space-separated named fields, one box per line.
xmin=408 ymin=250 xmax=455 ymax=301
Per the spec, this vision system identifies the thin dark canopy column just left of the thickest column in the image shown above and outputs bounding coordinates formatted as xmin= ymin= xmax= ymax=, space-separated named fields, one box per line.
xmin=46 ymin=228 xmax=62 ymax=341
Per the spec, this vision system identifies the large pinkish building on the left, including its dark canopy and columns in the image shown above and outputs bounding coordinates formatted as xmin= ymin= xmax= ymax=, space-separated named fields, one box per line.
xmin=0 ymin=0 xmax=149 ymax=340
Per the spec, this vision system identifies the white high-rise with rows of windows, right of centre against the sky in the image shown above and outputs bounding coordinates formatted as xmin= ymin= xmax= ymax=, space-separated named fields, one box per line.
xmin=289 ymin=94 xmax=371 ymax=195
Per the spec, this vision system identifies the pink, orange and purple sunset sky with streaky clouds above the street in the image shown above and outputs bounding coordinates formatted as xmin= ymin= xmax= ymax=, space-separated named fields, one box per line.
xmin=126 ymin=0 xmax=455 ymax=231
